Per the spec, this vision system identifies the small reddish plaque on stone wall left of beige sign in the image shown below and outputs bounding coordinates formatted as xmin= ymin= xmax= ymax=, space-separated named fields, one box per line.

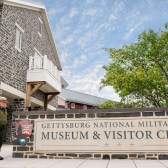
xmin=16 ymin=120 xmax=33 ymax=137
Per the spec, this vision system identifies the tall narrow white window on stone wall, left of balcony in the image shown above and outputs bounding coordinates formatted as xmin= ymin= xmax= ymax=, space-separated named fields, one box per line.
xmin=15 ymin=23 xmax=24 ymax=52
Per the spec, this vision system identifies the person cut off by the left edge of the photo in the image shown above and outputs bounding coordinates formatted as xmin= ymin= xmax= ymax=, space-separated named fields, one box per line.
xmin=0 ymin=97 xmax=7 ymax=160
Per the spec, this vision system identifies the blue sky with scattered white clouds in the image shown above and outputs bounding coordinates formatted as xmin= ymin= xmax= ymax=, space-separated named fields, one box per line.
xmin=28 ymin=0 xmax=168 ymax=100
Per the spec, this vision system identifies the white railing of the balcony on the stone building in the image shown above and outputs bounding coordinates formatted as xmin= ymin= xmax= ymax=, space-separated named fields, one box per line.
xmin=29 ymin=55 xmax=60 ymax=81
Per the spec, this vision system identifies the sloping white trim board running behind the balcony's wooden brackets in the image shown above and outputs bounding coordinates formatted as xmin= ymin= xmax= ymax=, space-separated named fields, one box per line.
xmin=0 ymin=82 xmax=56 ymax=111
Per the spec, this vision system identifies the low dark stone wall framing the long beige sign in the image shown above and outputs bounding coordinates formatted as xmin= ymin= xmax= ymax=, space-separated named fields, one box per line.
xmin=13 ymin=109 xmax=168 ymax=160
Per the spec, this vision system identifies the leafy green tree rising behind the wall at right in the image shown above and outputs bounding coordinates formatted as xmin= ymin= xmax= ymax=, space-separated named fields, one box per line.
xmin=102 ymin=25 xmax=168 ymax=107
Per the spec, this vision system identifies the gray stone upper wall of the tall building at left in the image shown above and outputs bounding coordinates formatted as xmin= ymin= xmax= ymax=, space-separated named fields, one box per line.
xmin=0 ymin=5 xmax=56 ymax=107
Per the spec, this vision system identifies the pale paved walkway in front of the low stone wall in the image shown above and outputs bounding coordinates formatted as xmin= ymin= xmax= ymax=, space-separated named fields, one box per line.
xmin=0 ymin=146 xmax=168 ymax=168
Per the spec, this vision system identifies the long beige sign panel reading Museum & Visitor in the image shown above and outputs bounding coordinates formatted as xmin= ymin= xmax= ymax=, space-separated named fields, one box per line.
xmin=34 ymin=117 xmax=168 ymax=153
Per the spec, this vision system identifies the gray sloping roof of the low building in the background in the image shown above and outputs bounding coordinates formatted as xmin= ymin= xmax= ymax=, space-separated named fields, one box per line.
xmin=58 ymin=89 xmax=108 ymax=106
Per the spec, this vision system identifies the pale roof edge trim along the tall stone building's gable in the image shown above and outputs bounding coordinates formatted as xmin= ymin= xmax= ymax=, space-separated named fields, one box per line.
xmin=0 ymin=0 xmax=62 ymax=70
